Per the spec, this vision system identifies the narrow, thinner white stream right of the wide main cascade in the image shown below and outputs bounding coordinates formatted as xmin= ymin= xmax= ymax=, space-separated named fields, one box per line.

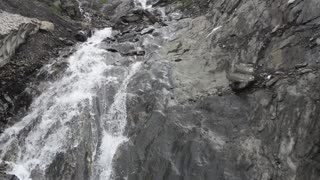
xmin=92 ymin=62 xmax=141 ymax=180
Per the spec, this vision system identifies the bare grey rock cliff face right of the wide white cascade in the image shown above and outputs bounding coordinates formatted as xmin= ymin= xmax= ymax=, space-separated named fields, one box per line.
xmin=3 ymin=0 xmax=320 ymax=180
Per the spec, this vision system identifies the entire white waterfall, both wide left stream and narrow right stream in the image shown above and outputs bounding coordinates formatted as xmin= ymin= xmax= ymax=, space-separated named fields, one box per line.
xmin=0 ymin=28 xmax=140 ymax=180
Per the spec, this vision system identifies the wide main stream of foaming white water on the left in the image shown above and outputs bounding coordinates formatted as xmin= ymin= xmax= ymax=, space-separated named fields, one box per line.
xmin=0 ymin=28 xmax=112 ymax=180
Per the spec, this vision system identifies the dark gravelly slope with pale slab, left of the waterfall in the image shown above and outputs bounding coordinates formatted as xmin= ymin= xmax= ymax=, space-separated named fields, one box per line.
xmin=0 ymin=0 xmax=87 ymax=132
